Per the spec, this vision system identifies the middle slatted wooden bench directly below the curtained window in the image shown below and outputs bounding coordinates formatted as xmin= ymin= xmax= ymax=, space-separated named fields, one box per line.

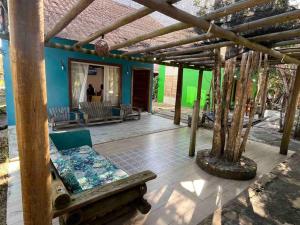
xmin=79 ymin=102 xmax=122 ymax=125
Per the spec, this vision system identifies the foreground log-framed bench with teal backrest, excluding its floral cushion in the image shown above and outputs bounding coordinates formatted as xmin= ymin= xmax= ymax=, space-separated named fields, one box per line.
xmin=50 ymin=130 xmax=156 ymax=225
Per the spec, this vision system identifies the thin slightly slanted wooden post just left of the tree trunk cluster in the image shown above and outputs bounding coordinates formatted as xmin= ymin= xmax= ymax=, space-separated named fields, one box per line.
xmin=189 ymin=70 xmax=203 ymax=157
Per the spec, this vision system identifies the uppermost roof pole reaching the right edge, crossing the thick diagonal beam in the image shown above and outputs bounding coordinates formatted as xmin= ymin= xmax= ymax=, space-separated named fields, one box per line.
xmin=124 ymin=10 xmax=300 ymax=55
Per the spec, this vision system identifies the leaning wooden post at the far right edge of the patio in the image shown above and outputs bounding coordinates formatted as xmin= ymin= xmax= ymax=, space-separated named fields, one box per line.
xmin=280 ymin=66 xmax=300 ymax=155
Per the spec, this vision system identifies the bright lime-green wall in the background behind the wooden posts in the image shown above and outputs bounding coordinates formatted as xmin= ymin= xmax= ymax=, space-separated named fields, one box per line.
xmin=158 ymin=65 xmax=212 ymax=108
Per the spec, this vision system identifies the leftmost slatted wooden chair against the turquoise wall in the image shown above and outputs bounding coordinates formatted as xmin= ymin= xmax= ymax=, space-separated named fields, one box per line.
xmin=48 ymin=107 xmax=80 ymax=130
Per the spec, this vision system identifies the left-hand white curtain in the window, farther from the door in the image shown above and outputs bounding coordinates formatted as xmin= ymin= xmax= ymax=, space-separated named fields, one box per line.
xmin=71 ymin=62 xmax=89 ymax=108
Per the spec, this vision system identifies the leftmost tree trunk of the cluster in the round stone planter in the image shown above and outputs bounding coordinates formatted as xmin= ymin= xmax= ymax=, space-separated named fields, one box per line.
xmin=211 ymin=49 xmax=222 ymax=157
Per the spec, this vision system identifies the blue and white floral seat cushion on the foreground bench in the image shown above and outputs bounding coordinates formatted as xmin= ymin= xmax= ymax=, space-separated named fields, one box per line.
xmin=50 ymin=143 xmax=128 ymax=193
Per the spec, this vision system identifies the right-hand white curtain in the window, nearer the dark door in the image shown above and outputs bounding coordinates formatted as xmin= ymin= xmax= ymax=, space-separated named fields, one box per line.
xmin=103 ymin=66 xmax=120 ymax=105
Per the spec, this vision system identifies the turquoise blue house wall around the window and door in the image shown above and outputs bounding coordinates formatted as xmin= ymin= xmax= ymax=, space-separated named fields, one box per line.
xmin=2 ymin=39 xmax=153 ymax=125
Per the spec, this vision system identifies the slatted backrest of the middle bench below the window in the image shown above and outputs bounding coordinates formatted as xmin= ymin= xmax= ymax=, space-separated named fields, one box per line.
xmin=79 ymin=102 xmax=112 ymax=120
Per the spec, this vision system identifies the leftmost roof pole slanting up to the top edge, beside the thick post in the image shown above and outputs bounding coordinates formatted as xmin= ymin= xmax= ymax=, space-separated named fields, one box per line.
xmin=45 ymin=0 xmax=94 ymax=41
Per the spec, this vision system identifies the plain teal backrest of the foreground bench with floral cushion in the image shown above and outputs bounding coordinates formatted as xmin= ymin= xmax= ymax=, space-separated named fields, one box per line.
xmin=49 ymin=129 xmax=93 ymax=150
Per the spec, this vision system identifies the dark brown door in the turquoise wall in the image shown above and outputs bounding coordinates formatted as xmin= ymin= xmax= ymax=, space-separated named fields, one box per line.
xmin=132 ymin=69 xmax=151 ymax=112
